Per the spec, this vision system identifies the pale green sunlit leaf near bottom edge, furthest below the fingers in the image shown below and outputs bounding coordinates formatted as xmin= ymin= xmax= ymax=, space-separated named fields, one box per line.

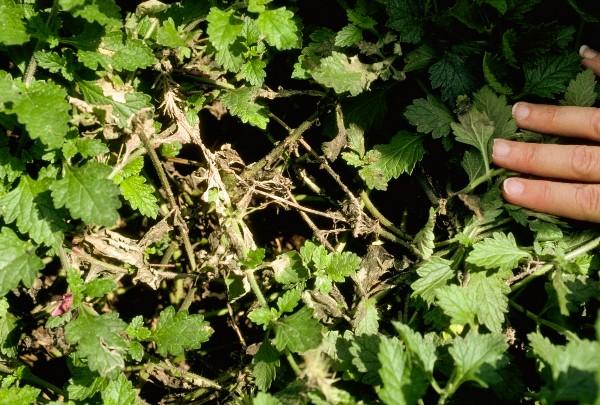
xmin=448 ymin=331 xmax=508 ymax=388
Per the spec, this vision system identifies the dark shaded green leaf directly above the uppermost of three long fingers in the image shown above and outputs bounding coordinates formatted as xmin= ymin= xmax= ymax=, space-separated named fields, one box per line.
xmin=523 ymin=53 xmax=579 ymax=98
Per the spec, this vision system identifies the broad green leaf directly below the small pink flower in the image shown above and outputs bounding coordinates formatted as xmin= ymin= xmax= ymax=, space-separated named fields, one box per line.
xmin=65 ymin=309 xmax=127 ymax=376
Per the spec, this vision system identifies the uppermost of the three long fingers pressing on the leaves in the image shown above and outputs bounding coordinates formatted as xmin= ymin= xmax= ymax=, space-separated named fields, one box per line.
xmin=513 ymin=102 xmax=600 ymax=141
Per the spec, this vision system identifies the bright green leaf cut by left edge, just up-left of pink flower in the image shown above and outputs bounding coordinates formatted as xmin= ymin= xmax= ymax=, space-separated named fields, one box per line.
xmin=0 ymin=227 xmax=44 ymax=296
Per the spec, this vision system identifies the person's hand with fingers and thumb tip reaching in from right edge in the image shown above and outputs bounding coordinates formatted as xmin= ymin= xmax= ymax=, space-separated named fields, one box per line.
xmin=492 ymin=45 xmax=600 ymax=222
